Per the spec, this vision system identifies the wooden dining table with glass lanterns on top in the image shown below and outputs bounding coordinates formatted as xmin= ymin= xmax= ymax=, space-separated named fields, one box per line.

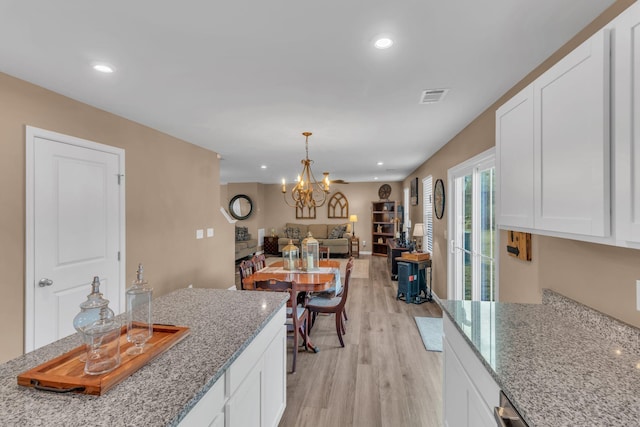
xmin=242 ymin=259 xmax=341 ymax=353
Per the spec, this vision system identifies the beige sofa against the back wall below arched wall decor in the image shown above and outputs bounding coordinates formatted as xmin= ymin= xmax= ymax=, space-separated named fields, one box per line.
xmin=278 ymin=223 xmax=351 ymax=255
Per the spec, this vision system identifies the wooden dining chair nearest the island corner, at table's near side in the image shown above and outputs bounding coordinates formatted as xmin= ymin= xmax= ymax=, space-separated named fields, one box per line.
xmin=253 ymin=279 xmax=309 ymax=373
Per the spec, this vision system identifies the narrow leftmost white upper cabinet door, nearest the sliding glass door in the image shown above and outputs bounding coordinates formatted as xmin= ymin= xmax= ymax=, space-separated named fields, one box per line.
xmin=496 ymin=85 xmax=534 ymax=228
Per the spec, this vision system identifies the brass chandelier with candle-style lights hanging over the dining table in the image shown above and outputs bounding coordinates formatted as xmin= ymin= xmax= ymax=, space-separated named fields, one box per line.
xmin=282 ymin=132 xmax=330 ymax=209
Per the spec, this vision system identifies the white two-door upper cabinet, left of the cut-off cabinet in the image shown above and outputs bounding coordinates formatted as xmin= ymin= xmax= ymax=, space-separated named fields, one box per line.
xmin=496 ymin=28 xmax=611 ymax=240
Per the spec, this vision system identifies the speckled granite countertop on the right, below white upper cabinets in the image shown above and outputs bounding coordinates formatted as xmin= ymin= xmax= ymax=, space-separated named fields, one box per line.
xmin=439 ymin=290 xmax=640 ymax=427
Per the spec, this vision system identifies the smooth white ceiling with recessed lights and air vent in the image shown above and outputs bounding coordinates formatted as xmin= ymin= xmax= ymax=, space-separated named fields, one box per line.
xmin=0 ymin=0 xmax=614 ymax=183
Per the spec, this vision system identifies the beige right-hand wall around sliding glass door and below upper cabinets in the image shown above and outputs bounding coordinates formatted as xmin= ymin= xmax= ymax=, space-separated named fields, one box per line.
xmin=403 ymin=0 xmax=640 ymax=327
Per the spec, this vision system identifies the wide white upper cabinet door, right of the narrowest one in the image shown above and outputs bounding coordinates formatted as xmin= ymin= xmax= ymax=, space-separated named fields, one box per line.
xmin=534 ymin=29 xmax=610 ymax=237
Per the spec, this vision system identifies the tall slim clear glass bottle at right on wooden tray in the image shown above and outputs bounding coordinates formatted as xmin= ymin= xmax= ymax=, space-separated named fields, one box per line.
xmin=126 ymin=264 xmax=153 ymax=355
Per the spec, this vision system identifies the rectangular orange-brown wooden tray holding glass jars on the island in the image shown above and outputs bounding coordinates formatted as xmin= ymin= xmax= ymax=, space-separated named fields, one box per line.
xmin=18 ymin=325 xmax=190 ymax=396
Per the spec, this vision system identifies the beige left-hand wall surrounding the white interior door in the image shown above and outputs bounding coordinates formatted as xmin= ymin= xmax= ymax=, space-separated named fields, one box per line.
xmin=0 ymin=73 xmax=234 ymax=362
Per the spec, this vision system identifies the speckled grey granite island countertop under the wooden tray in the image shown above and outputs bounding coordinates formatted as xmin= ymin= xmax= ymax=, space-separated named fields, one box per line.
xmin=0 ymin=289 xmax=288 ymax=427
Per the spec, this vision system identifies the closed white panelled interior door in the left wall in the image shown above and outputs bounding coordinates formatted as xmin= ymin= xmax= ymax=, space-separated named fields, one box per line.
xmin=25 ymin=128 xmax=124 ymax=351
